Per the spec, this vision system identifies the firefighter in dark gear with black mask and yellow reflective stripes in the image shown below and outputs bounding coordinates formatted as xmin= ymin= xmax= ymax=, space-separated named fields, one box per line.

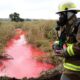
xmin=53 ymin=0 xmax=80 ymax=80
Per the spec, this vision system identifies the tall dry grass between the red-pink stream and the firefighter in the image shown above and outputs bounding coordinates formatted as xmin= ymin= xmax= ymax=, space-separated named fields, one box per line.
xmin=22 ymin=20 xmax=56 ymax=52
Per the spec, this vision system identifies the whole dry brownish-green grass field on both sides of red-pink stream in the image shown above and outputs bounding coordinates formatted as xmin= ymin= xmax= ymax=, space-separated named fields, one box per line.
xmin=0 ymin=20 xmax=61 ymax=63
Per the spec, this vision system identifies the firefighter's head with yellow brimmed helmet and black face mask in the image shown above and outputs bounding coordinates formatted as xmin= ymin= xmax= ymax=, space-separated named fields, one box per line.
xmin=57 ymin=1 xmax=80 ymax=26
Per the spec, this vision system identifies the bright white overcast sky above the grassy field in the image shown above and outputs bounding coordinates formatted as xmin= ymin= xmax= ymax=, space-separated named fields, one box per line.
xmin=0 ymin=0 xmax=80 ymax=19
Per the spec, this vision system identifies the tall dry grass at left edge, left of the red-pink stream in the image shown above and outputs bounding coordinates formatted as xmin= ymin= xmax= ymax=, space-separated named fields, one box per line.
xmin=0 ymin=22 xmax=15 ymax=55
